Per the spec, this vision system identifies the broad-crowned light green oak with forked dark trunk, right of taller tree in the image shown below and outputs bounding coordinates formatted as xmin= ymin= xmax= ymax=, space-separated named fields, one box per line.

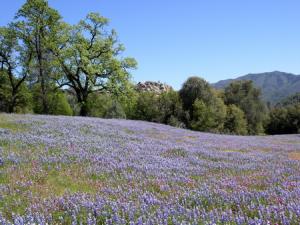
xmin=52 ymin=13 xmax=136 ymax=116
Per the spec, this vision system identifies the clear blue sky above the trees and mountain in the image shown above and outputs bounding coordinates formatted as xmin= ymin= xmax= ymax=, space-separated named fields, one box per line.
xmin=0 ymin=0 xmax=300 ymax=89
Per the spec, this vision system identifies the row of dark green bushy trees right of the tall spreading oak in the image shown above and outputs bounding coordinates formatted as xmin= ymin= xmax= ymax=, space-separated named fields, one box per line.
xmin=131 ymin=77 xmax=300 ymax=135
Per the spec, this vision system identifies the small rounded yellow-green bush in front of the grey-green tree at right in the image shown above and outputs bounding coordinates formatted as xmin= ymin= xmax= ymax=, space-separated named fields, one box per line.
xmin=224 ymin=105 xmax=248 ymax=135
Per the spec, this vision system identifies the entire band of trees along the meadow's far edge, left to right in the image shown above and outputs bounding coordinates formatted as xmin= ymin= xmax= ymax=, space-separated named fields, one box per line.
xmin=0 ymin=0 xmax=300 ymax=135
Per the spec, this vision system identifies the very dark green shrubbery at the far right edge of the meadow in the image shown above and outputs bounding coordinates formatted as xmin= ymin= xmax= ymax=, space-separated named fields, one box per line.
xmin=266 ymin=104 xmax=300 ymax=134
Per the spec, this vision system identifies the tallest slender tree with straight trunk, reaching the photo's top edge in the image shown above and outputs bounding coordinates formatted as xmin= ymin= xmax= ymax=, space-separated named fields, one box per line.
xmin=14 ymin=0 xmax=61 ymax=114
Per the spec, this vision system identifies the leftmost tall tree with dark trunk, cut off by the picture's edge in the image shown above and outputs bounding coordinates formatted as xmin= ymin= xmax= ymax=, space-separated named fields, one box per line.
xmin=0 ymin=26 xmax=32 ymax=113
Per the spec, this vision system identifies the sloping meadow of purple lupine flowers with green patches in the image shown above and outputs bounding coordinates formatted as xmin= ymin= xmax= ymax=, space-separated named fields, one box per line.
xmin=0 ymin=114 xmax=300 ymax=225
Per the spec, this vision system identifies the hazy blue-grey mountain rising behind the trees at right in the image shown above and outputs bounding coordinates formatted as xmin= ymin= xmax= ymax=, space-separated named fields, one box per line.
xmin=212 ymin=71 xmax=300 ymax=104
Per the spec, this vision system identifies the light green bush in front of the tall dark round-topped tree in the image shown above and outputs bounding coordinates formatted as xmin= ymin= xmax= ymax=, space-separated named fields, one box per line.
xmin=191 ymin=97 xmax=226 ymax=132
